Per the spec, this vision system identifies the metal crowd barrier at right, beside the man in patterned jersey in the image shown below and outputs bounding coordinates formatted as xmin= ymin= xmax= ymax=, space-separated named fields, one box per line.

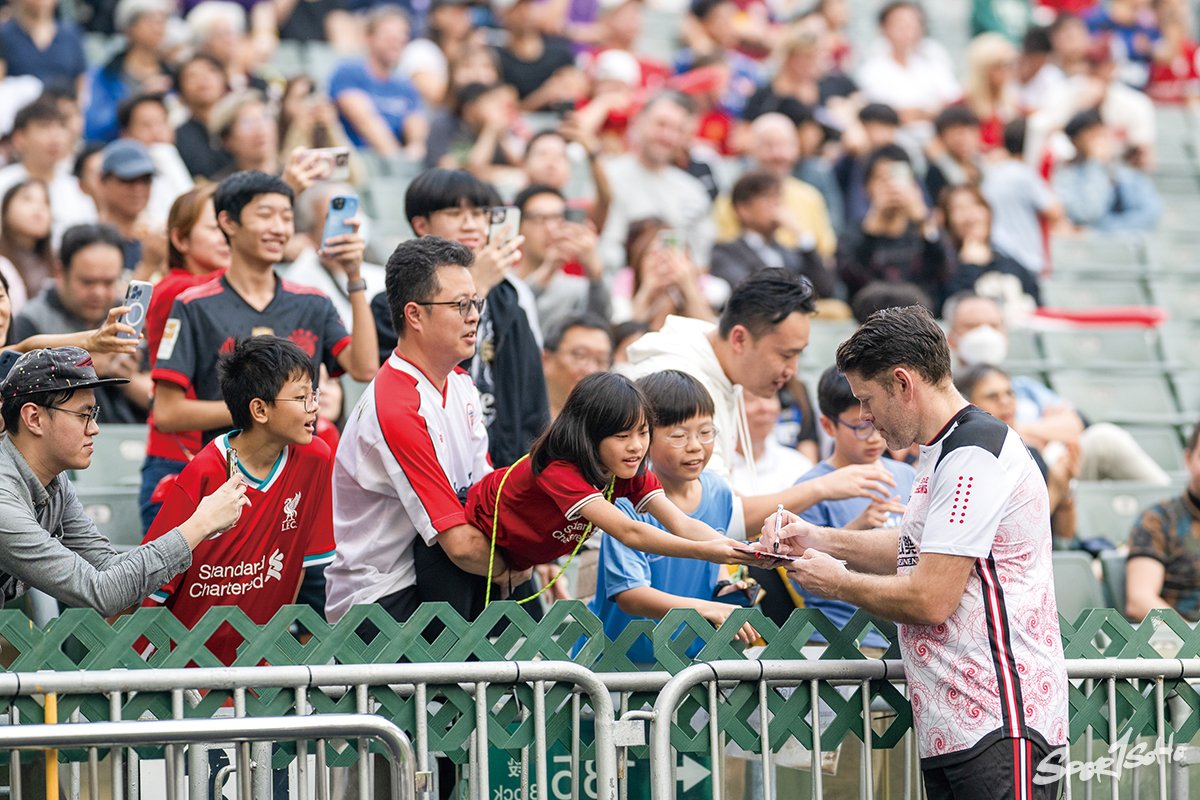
xmin=647 ymin=658 xmax=1200 ymax=800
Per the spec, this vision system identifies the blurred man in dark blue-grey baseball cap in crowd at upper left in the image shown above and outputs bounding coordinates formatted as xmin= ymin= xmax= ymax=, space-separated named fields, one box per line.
xmin=98 ymin=139 xmax=158 ymax=275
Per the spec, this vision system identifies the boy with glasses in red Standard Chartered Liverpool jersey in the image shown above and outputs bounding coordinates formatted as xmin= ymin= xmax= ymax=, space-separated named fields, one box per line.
xmin=143 ymin=336 xmax=334 ymax=664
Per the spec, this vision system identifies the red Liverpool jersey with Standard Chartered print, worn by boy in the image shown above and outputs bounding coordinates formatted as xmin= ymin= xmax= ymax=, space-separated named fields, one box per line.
xmin=143 ymin=434 xmax=334 ymax=664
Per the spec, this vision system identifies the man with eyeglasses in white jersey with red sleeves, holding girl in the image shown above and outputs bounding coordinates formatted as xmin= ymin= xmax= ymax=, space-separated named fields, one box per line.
xmin=325 ymin=236 xmax=526 ymax=621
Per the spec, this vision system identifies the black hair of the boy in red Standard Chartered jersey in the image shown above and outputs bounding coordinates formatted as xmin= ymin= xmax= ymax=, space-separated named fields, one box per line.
xmin=217 ymin=336 xmax=317 ymax=431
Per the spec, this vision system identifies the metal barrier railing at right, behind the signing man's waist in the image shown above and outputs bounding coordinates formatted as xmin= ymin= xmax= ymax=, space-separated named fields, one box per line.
xmin=649 ymin=658 xmax=1200 ymax=800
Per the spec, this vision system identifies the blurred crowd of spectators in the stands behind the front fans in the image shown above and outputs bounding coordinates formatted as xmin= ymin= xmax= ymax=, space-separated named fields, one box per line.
xmin=0 ymin=0 xmax=1200 ymax=613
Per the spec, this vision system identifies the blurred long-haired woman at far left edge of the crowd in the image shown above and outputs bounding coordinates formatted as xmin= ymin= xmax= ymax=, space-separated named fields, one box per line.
xmin=0 ymin=179 xmax=54 ymax=314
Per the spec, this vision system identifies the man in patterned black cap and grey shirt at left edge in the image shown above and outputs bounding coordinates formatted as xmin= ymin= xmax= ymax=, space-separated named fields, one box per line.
xmin=0 ymin=347 xmax=248 ymax=615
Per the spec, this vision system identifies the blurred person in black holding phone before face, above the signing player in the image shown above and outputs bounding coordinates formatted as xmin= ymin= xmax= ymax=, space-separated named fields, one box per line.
xmin=838 ymin=145 xmax=946 ymax=308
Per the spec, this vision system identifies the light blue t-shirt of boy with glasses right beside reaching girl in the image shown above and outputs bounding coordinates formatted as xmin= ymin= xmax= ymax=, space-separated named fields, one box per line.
xmin=589 ymin=473 xmax=733 ymax=663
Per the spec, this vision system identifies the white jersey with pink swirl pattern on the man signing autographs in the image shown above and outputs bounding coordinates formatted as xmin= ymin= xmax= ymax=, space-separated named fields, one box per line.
xmin=896 ymin=405 xmax=1068 ymax=766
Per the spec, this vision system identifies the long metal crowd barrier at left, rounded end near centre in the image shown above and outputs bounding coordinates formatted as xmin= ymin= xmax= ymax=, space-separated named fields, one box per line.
xmin=0 ymin=661 xmax=617 ymax=800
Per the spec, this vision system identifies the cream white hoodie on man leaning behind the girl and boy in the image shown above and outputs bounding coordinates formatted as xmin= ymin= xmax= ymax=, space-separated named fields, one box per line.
xmin=620 ymin=317 xmax=744 ymax=481
